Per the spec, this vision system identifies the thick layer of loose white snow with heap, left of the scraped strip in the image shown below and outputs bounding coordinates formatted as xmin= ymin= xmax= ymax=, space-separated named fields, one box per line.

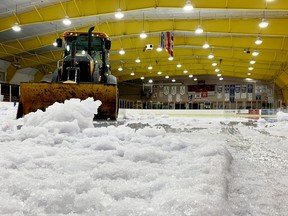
xmin=0 ymin=99 xmax=232 ymax=216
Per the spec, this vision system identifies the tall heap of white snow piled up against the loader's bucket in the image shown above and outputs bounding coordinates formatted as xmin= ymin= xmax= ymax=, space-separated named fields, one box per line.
xmin=24 ymin=98 xmax=101 ymax=133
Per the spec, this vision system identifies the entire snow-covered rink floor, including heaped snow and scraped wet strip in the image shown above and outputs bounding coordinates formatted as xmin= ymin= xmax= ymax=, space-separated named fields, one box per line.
xmin=0 ymin=99 xmax=288 ymax=216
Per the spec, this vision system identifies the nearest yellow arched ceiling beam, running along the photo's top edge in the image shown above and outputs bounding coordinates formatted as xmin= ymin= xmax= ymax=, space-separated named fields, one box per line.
xmin=0 ymin=0 xmax=288 ymax=32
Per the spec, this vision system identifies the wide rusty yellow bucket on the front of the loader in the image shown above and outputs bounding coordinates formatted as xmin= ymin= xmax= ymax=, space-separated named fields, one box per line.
xmin=16 ymin=83 xmax=118 ymax=120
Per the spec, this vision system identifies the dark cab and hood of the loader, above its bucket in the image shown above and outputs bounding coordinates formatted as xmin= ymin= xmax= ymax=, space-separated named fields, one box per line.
xmin=58 ymin=32 xmax=111 ymax=83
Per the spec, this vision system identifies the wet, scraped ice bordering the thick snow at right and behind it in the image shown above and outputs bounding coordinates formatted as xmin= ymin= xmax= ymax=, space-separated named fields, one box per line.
xmin=95 ymin=119 xmax=288 ymax=216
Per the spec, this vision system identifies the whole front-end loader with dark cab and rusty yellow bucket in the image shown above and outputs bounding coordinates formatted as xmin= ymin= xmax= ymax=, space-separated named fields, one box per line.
xmin=16 ymin=27 xmax=118 ymax=120
